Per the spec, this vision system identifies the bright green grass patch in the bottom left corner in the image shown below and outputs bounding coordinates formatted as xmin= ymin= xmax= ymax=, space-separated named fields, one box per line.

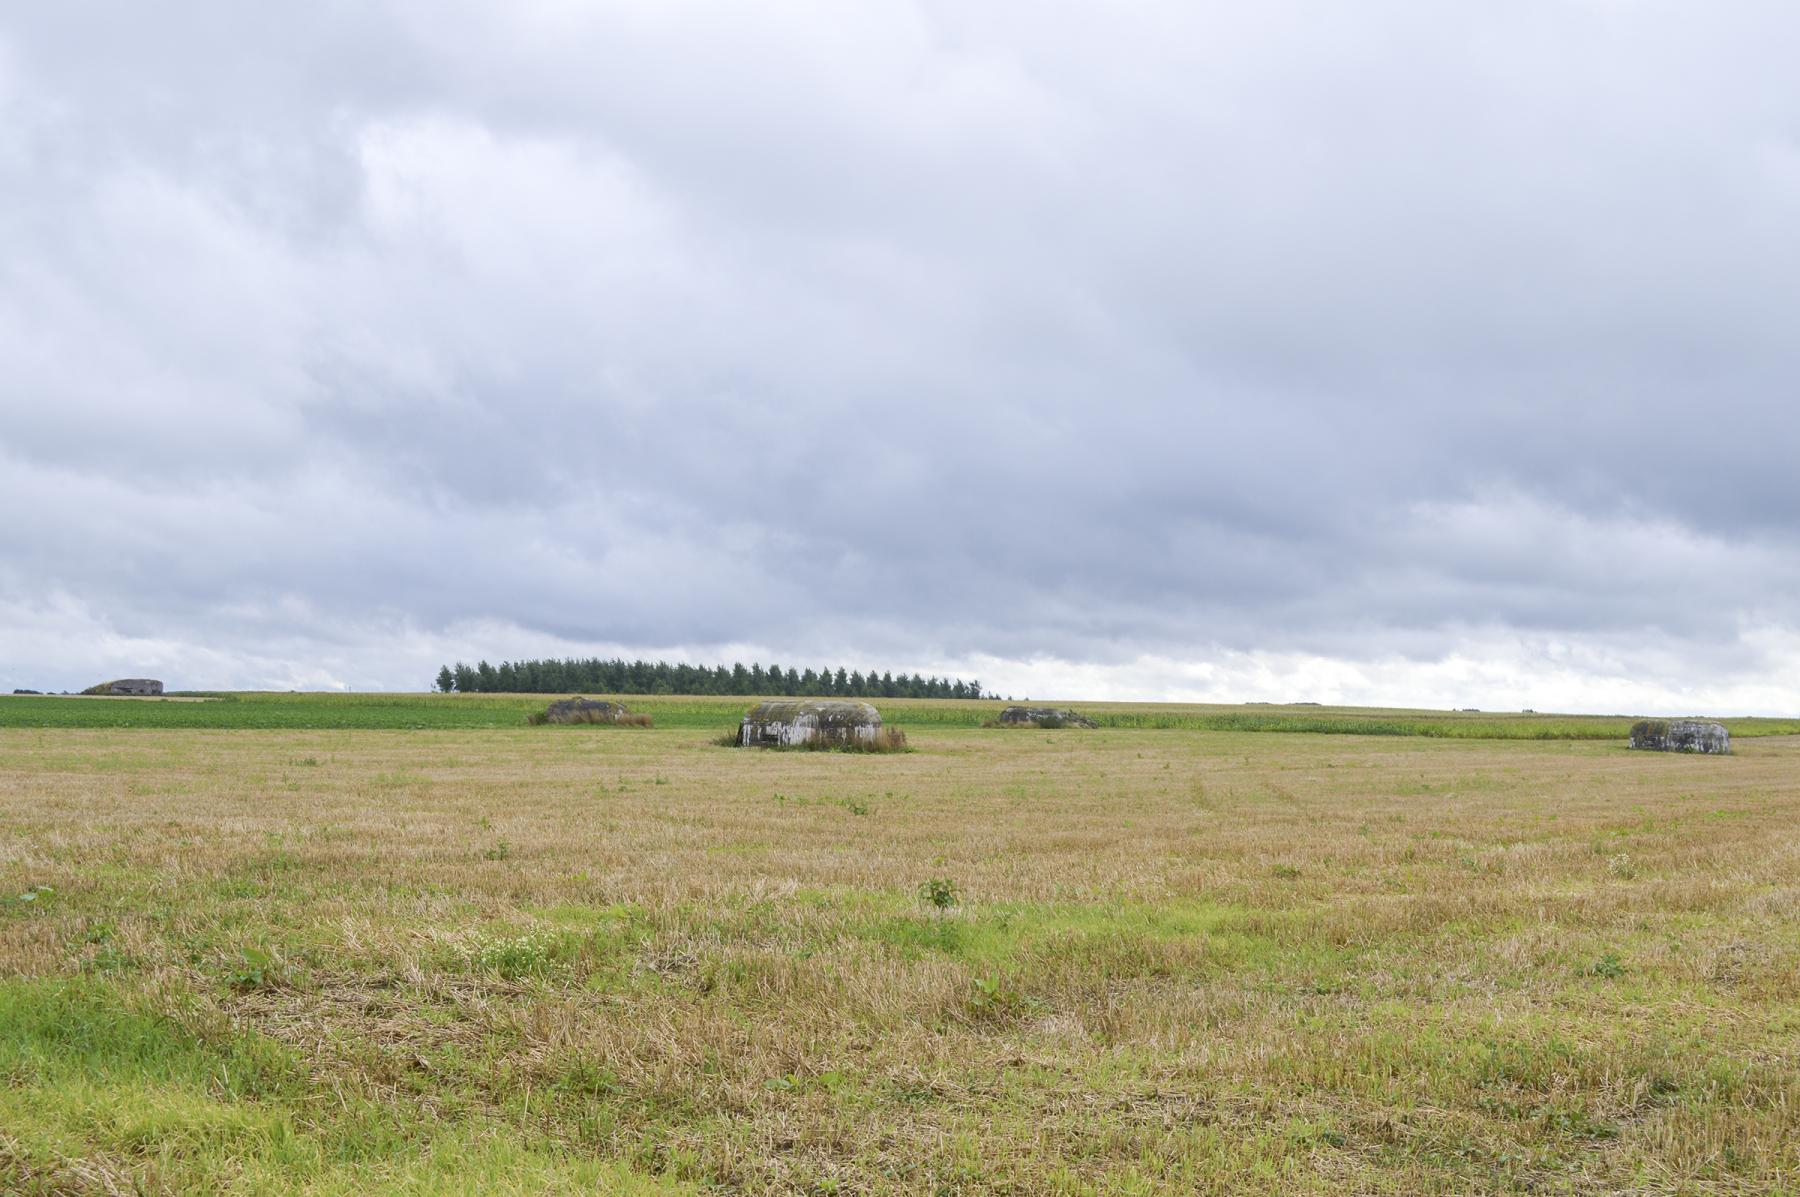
xmin=0 ymin=979 xmax=695 ymax=1195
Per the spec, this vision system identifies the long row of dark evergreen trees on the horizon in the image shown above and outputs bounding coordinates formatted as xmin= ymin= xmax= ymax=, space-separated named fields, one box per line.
xmin=437 ymin=657 xmax=981 ymax=698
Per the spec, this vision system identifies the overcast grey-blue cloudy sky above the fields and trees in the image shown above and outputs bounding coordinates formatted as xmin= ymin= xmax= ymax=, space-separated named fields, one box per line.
xmin=0 ymin=0 xmax=1800 ymax=713
